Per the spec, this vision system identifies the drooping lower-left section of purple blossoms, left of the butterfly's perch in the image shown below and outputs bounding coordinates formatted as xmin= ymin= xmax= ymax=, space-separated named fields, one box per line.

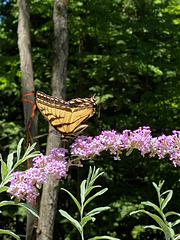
xmin=8 ymin=148 xmax=67 ymax=202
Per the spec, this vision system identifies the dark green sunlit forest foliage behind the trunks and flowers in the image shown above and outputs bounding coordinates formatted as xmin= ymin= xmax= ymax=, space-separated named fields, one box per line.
xmin=0 ymin=0 xmax=180 ymax=240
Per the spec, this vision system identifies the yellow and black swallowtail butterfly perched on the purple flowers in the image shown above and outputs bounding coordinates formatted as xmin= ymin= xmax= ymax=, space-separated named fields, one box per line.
xmin=36 ymin=91 xmax=96 ymax=141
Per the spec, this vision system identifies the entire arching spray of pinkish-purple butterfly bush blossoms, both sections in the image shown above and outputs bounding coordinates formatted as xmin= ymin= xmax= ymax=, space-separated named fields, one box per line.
xmin=8 ymin=126 xmax=180 ymax=202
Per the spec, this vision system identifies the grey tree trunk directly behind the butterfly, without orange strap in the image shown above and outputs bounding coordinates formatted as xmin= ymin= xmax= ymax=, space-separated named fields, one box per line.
xmin=37 ymin=0 xmax=68 ymax=240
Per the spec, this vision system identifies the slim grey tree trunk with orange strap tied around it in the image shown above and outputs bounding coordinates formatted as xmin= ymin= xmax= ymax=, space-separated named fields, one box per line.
xmin=18 ymin=0 xmax=39 ymax=240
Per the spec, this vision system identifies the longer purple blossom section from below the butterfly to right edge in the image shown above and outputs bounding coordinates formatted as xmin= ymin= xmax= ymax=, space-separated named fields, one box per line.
xmin=71 ymin=126 xmax=180 ymax=166
